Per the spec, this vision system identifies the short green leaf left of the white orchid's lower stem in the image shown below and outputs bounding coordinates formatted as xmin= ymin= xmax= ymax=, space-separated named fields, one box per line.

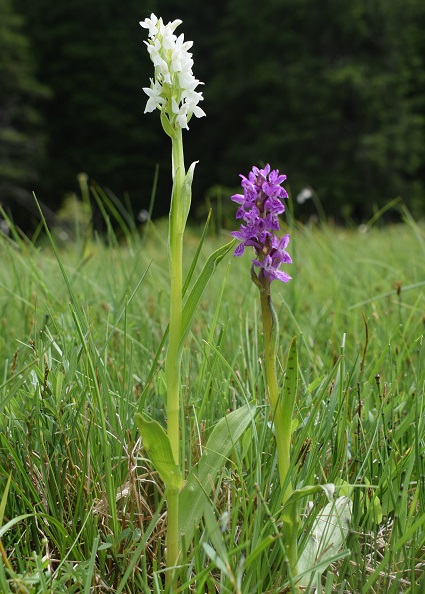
xmin=135 ymin=413 xmax=183 ymax=490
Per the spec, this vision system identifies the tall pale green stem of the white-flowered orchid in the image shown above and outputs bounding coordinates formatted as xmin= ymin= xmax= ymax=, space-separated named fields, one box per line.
xmin=165 ymin=128 xmax=185 ymax=591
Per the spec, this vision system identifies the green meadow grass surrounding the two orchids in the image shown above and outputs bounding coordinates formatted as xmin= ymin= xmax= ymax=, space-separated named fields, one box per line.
xmin=0 ymin=205 xmax=425 ymax=594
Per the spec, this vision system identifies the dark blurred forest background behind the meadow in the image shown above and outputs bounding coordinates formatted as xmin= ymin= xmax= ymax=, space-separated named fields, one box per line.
xmin=0 ymin=0 xmax=425 ymax=225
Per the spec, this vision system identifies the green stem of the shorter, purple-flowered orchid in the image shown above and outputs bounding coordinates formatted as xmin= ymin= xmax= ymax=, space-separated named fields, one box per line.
xmin=256 ymin=277 xmax=299 ymax=592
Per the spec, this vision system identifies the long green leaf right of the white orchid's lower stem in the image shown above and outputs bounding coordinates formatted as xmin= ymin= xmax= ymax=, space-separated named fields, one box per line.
xmin=179 ymin=403 xmax=256 ymax=543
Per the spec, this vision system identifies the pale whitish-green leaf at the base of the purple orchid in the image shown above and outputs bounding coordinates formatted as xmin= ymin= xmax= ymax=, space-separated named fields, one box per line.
xmin=298 ymin=497 xmax=352 ymax=588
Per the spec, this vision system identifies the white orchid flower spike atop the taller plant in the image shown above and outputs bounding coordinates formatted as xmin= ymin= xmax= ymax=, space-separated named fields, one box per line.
xmin=140 ymin=14 xmax=205 ymax=134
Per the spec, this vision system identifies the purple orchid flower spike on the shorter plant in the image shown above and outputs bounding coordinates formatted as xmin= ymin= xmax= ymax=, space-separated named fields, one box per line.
xmin=231 ymin=164 xmax=292 ymax=282
